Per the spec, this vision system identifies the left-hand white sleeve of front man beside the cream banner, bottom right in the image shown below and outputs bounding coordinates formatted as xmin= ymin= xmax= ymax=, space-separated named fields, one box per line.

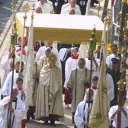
xmin=74 ymin=102 xmax=85 ymax=128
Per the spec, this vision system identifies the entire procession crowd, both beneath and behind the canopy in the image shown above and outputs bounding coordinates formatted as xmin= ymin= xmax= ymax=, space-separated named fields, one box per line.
xmin=0 ymin=0 xmax=128 ymax=128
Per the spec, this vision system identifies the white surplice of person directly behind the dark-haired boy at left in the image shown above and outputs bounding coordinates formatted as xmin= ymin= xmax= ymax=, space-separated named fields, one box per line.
xmin=1 ymin=70 xmax=23 ymax=96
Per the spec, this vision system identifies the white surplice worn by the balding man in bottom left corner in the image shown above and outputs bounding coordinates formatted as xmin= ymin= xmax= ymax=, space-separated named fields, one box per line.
xmin=0 ymin=96 xmax=26 ymax=128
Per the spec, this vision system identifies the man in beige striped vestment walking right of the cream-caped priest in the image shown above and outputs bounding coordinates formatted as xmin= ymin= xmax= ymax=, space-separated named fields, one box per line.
xmin=67 ymin=58 xmax=90 ymax=123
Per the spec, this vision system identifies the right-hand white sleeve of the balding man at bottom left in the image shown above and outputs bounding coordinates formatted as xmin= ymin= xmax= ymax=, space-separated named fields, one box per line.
xmin=14 ymin=102 xmax=26 ymax=122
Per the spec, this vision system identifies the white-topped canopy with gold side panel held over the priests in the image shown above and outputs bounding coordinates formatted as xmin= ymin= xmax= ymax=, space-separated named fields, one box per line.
xmin=16 ymin=13 xmax=104 ymax=44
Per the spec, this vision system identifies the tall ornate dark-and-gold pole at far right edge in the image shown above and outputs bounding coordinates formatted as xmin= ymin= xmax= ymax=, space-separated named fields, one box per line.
xmin=117 ymin=0 xmax=127 ymax=128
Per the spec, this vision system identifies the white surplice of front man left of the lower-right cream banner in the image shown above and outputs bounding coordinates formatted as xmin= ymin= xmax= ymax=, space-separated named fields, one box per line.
xmin=74 ymin=101 xmax=92 ymax=128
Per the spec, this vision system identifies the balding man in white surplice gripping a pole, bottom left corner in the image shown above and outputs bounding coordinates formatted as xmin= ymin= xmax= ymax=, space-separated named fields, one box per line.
xmin=0 ymin=88 xmax=26 ymax=128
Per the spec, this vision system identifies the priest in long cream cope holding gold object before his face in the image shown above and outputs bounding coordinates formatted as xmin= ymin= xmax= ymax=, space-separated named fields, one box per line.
xmin=35 ymin=54 xmax=64 ymax=124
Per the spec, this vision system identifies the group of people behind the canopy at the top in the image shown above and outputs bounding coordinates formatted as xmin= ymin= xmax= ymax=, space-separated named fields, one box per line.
xmin=35 ymin=0 xmax=98 ymax=15
